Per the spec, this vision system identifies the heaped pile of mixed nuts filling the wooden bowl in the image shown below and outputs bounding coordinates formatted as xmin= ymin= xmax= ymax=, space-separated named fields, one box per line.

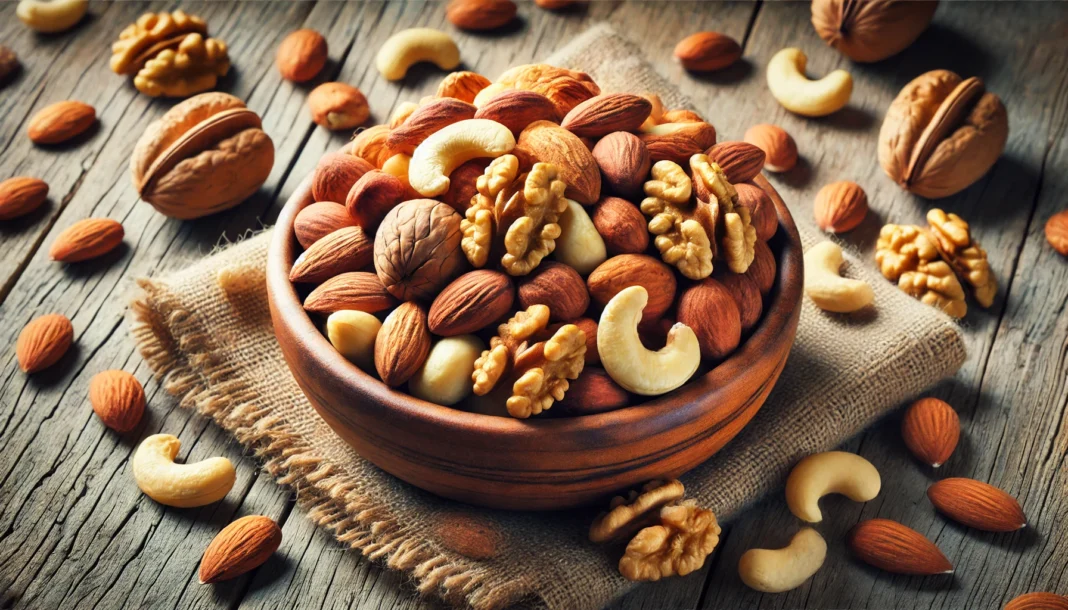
xmin=289 ymin=64 xmax=778 ymax=418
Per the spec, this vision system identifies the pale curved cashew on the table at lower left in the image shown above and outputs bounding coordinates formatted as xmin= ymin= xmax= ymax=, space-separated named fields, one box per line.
xmin=134 ymin=434 xmax=237 ymax=509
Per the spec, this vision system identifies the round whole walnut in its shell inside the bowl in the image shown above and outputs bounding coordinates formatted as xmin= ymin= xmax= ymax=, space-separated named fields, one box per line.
xmin=375 ymin=199 xmax=466 ymax=301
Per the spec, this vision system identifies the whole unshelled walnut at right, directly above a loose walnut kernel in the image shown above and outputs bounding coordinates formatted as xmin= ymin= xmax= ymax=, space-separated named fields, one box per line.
xmin=879 ymin=69 xmax=1008 ymax=199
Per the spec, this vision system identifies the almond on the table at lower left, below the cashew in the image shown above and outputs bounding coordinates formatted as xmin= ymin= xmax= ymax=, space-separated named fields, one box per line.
xmin=200 ymin=515 xmax=282 ymax=584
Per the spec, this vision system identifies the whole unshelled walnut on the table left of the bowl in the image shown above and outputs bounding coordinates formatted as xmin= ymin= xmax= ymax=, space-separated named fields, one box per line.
xmin=130 ymin=92 xmax=274 ymax=219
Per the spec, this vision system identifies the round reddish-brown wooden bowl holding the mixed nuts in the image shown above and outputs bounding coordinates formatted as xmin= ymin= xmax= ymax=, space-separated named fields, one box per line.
xmin=267 ymin=176 xmax=802 ymax=511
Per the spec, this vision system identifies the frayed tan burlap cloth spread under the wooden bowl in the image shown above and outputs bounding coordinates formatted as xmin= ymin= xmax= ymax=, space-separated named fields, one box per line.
xmin=131 ymin=26 xmax=964 ymax=610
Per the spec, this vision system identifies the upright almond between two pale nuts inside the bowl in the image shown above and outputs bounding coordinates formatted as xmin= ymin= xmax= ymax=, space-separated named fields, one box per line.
xmin=375 ymin=301 xmax=430 ymax=388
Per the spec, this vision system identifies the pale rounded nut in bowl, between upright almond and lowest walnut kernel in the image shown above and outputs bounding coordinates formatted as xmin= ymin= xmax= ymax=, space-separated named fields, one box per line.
xmin=408 ymin=334 xmax=486 ymax=406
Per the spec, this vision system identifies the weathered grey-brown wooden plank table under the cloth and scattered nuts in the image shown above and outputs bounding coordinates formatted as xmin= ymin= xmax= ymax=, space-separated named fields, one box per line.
xmin=0 ymin=1 xmax=1068 ymax=609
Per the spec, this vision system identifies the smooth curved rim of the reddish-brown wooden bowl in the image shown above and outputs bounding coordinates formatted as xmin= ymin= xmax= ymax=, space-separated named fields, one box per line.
xmin=266 ymin=174 xmax=803 ymax=449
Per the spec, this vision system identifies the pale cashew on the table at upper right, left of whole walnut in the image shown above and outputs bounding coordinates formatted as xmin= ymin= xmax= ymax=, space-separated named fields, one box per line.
xmin=768 ymin=49 xmax=853 ymax=116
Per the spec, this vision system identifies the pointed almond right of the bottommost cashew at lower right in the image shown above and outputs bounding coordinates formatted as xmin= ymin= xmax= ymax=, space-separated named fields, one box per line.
xmin=849 ymin=519 xmax=953 ymax=575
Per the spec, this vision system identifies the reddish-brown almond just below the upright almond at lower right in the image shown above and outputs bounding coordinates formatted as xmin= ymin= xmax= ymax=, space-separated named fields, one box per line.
xmin=927 ymin=478 xmax=1027 ymax=532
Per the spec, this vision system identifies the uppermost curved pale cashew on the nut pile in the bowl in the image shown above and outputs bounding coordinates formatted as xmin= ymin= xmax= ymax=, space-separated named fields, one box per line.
xmin=408 ymin=119 xmax=516 ymax=197
